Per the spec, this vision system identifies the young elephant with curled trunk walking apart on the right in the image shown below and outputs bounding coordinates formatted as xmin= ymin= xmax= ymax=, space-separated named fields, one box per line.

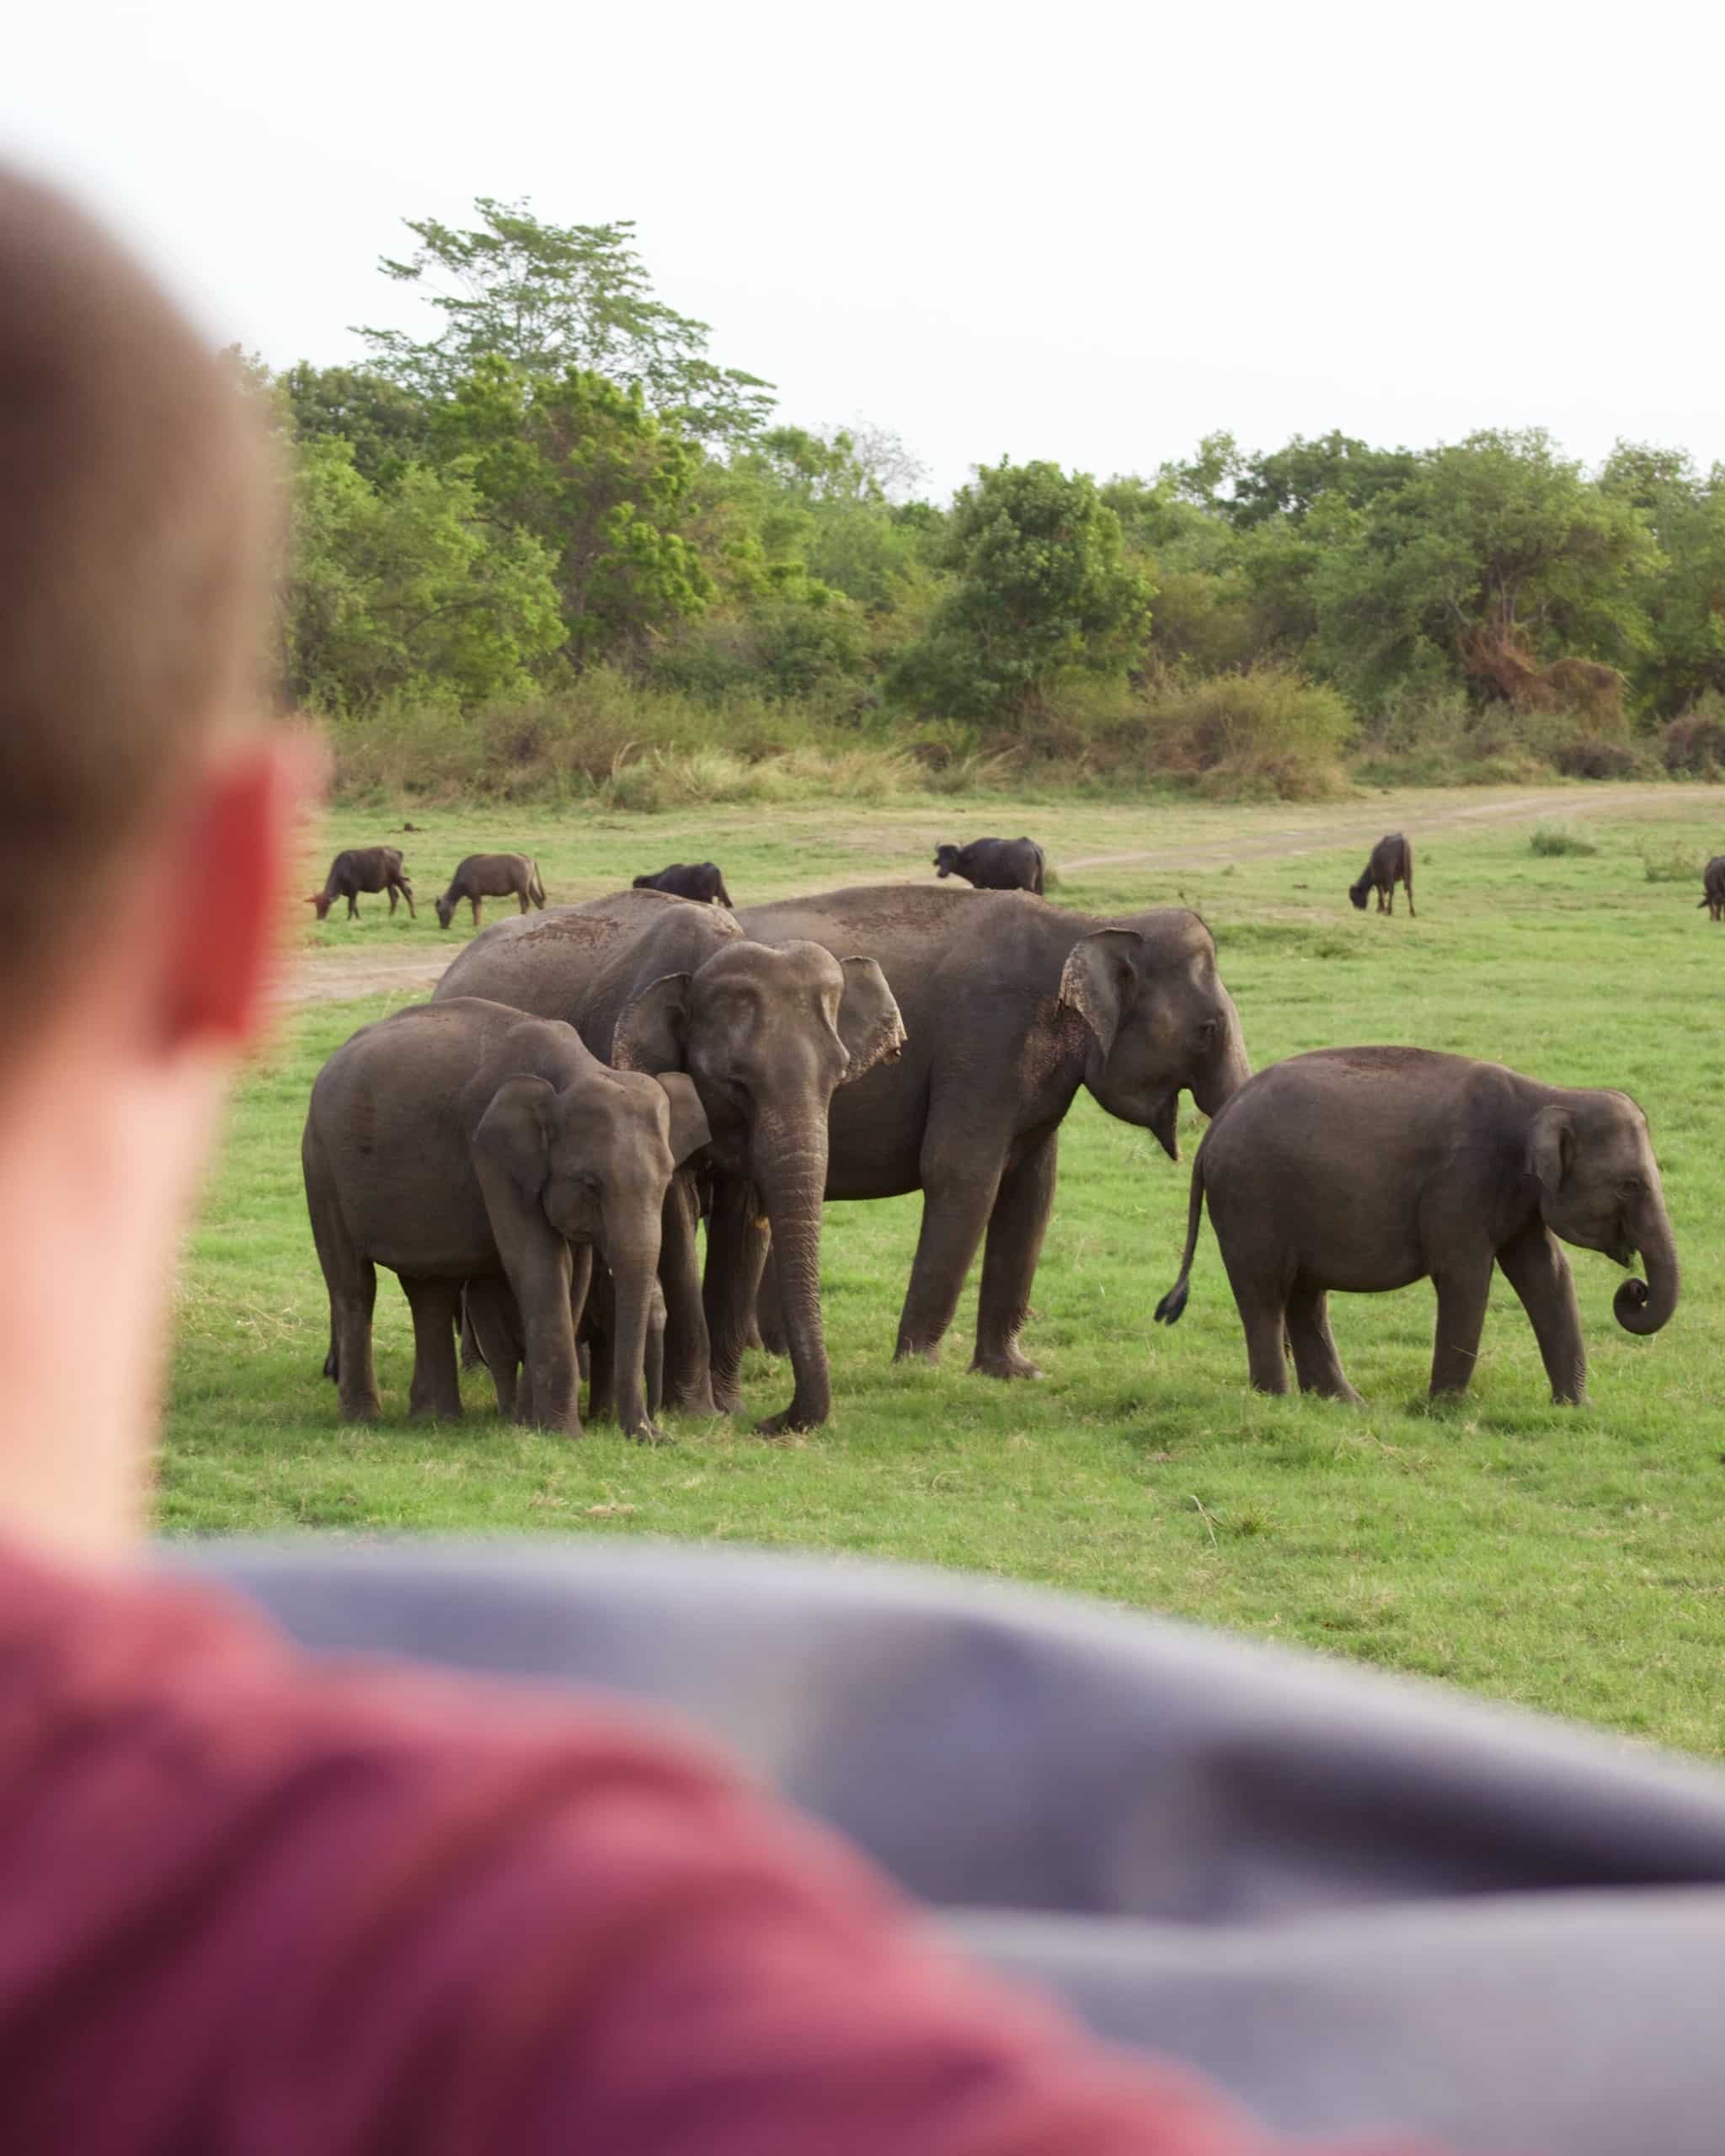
xmin=1156 ymin=1048 xmax=1678 ymax=1406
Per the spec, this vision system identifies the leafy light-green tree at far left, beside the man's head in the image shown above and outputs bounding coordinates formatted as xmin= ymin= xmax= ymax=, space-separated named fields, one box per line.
xmin=280 ymin=438 xmax=565 ymax=713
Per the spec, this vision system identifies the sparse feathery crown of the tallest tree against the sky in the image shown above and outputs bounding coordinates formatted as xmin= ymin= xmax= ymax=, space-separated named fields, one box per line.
xmin=358 ymin=194 xmax=774 ymax=442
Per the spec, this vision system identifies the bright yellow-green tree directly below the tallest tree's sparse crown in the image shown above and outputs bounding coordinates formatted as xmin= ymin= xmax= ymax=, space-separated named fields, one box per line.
xmin=431 ymin=358 xmax=713 ymax=662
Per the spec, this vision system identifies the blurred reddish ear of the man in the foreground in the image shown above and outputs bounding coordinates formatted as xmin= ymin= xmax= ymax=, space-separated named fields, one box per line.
xmin=164 ymin=731 xmax=321 ymax=1048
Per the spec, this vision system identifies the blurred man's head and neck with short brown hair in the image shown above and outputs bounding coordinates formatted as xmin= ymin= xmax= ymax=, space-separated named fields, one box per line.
xmin=0 ymin=168 xmax=293 ymax=1552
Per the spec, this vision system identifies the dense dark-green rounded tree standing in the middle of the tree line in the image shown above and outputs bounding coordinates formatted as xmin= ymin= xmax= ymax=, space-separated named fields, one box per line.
xmin=897 ymin=457 xmax=1151 ymax=718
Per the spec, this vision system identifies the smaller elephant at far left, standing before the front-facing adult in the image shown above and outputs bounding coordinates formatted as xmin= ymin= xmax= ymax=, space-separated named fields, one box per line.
xmin=302 ymin=996 xmax=709 ymax=1438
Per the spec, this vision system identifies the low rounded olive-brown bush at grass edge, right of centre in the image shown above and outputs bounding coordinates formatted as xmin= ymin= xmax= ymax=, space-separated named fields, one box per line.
xmin=1145 ymin=664 xmax=1354 ymax=800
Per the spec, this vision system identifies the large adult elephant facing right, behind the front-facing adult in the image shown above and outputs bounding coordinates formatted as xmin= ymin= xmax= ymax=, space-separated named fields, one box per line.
xmin=738 ymin=884 xmax=1251 ymax=1378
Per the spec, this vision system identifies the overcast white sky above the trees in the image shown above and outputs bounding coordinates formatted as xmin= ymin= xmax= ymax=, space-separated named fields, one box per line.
xmin=0 ymin=0 xmax=1725 ymax=489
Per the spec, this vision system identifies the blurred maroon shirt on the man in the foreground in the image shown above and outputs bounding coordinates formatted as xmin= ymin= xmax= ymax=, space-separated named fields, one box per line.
xmin=0 ymin=1555 xmax=1431 ymax=2156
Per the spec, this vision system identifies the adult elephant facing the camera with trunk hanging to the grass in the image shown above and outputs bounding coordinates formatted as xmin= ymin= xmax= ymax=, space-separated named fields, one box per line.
xmin=434 ymin=890 xmax=904 ymax=1433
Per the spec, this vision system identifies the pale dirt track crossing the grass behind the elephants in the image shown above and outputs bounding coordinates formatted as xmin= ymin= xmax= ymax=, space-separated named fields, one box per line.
xmin=276 ymin=785 xmax=1693 ymax=1005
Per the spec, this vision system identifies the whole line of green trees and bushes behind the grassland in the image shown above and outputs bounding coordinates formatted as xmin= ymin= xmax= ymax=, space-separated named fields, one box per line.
xmin=232 ymin=199 xmax=1725 ymax=793
